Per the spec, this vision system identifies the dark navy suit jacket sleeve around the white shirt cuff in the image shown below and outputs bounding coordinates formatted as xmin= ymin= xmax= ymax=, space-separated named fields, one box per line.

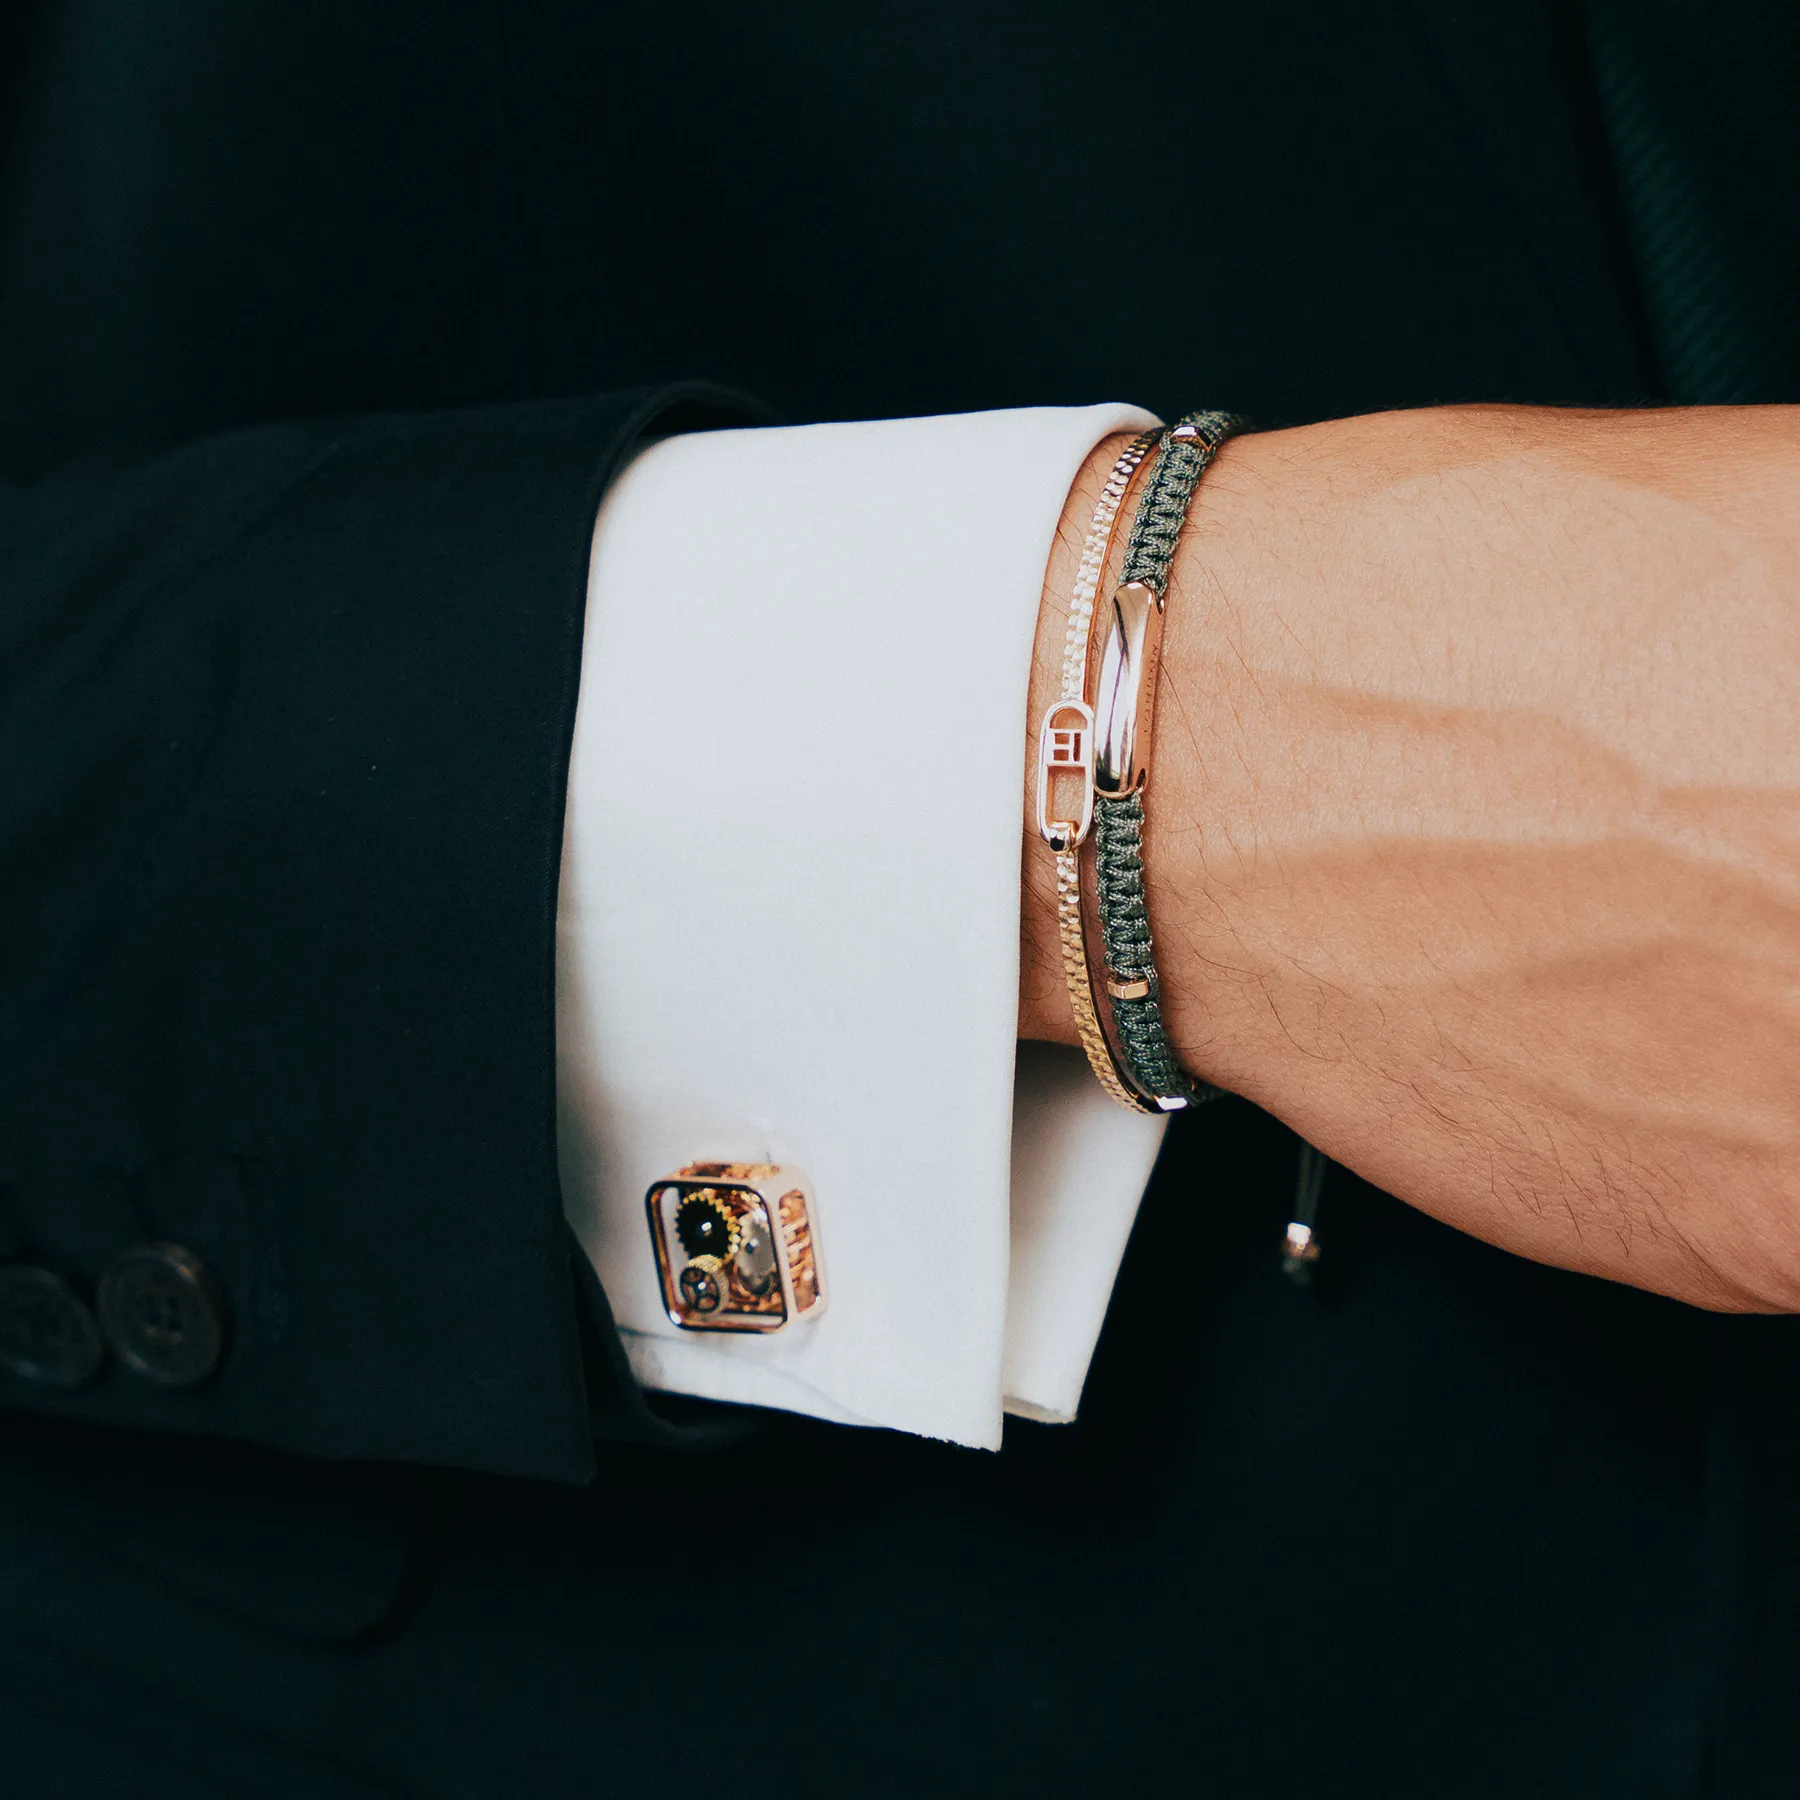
xmin=0 ymin=387 xmax=742 ymax=1480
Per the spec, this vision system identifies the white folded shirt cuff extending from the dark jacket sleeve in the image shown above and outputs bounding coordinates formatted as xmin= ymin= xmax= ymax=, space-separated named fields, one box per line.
xmin=556 ymin=405 xmax=1165 ymax=1447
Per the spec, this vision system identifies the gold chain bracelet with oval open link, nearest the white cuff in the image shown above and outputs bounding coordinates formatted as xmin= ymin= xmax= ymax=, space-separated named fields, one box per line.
xmin=1037 ymin=432 xmax=1161 ymax=1112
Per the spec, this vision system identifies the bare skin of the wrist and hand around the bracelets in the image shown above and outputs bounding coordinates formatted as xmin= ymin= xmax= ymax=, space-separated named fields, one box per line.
xmin=1019 ymin=407 xmax=1800 ymax=1312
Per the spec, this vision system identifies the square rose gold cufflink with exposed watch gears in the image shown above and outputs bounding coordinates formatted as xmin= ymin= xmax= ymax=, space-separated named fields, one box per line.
xmin=644 ymin=1163 xmax=824 ymax=1332
